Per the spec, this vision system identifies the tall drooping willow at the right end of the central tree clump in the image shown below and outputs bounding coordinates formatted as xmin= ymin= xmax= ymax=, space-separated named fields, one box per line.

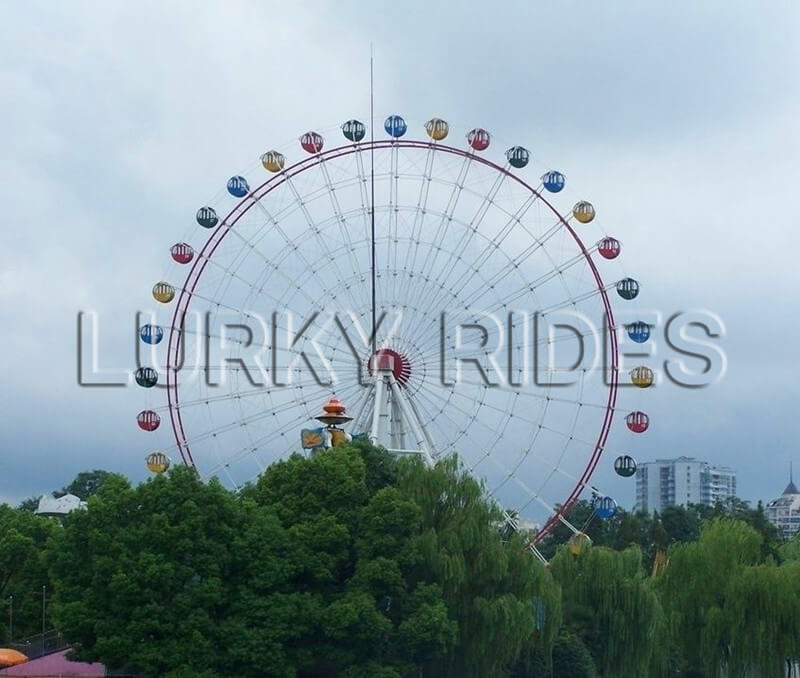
xmin=397 ymin=457 xmax=561 ymax=678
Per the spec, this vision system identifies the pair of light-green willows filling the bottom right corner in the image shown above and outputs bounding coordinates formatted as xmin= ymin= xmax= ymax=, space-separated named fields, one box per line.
xmin=658 ymin=519 xmax=800 ymax=676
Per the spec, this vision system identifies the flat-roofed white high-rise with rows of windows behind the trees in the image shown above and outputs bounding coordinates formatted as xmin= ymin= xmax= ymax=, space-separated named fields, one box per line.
xmin=636 ymin=457 xmax=736 ymax=512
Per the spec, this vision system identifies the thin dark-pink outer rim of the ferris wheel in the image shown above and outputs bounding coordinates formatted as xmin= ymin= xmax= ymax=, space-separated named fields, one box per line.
xmin=166 ymin=138 xmax=619 ymax=542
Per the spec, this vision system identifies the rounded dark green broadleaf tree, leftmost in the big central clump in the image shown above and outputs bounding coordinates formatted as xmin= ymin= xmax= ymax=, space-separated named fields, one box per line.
xmin=52 ymin=467 xmax=245 ymax=675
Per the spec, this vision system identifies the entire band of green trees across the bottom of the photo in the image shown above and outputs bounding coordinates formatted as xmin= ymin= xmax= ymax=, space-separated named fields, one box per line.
xmin=0 ymin=452 xmax=800 ymax=678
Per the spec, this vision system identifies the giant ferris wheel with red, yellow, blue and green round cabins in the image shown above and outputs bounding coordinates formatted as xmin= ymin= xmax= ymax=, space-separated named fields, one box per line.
xmin=135 ymin=115 xmax=654 ymax=555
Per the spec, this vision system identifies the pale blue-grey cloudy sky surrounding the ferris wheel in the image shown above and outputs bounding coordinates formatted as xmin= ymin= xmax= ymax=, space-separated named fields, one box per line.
xmin=0 ymin=0 xmax=800 ymax=505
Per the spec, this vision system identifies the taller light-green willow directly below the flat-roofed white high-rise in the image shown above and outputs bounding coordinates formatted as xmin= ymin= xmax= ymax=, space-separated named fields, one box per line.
xmin=657 ymin=519 xmax=761 ymax=676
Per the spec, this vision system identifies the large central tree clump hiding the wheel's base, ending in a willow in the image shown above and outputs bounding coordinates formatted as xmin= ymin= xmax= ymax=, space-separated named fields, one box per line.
xmin=52 ymin=444 xmax=560 ymax=678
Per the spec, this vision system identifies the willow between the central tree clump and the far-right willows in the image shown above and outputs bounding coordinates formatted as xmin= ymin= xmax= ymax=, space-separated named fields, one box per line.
xmin=551 ymin=547 xmax=667 ymax=678
